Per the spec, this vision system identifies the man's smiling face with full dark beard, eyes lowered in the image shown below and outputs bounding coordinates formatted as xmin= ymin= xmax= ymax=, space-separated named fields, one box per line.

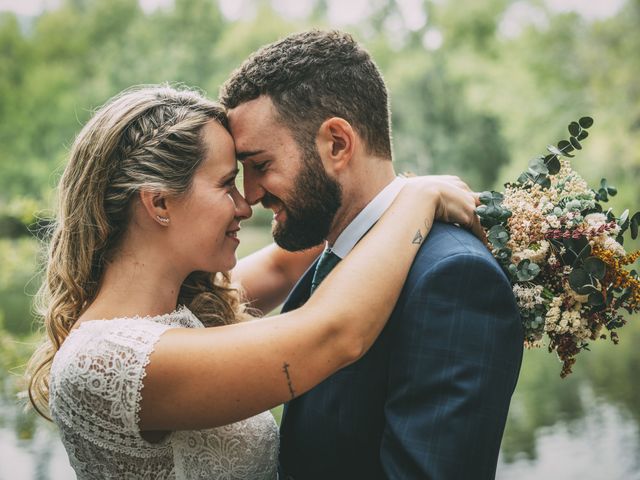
xmin=229 ymin=96 xmax=342 ymax=251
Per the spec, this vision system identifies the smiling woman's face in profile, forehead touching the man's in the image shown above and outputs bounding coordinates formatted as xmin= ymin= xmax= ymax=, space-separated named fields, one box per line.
xmin=170 ymin=121 xmax=251 ymax=272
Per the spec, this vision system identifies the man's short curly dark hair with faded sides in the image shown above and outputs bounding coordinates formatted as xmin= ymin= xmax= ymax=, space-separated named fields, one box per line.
xmin=220 ymin=30 xmax=391 ymax=159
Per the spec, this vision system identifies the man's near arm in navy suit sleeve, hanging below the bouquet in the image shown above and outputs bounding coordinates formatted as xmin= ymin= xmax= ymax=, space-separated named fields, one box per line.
xmin=380 ymin=252 xmax=523 ymax=480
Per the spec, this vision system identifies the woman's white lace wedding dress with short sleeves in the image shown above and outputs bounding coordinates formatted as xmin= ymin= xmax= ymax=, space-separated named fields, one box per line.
xmin=49 ymin=307 xmax=278 ymax=480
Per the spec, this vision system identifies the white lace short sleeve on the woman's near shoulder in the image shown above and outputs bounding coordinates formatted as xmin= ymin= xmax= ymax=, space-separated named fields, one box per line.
xmin=49 ymin=319 xmax=173 ymax=457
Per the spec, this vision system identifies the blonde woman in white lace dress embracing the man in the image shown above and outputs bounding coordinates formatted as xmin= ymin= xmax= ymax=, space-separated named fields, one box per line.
xmin=28 ymin=87 xmax=476 ymax=480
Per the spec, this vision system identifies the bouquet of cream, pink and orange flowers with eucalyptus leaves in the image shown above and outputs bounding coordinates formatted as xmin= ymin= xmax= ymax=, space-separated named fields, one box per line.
xmin=477 ymin=117 xmax=640 ymax=377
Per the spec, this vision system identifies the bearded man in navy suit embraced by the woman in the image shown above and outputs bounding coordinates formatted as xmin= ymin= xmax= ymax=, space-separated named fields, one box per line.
xmin=221 ymin=31 xmax=523 ymax=480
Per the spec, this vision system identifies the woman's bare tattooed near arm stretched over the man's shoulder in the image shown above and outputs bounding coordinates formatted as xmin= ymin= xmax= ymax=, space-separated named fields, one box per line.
xmin=139 ymin=176 xmax=477 ymax=430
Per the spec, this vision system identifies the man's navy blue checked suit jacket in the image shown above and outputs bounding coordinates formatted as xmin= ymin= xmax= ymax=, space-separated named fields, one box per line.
xmin=280 ymin=223 xmax=523 ymax=480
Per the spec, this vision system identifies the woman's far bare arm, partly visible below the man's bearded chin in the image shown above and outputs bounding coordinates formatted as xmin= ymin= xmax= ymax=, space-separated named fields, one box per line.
xmin=231 ymin=243 xmax=324 ymax=314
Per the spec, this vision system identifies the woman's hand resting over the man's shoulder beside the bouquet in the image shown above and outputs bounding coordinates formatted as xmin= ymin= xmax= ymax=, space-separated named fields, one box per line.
xmin=407 ymin=175 xmax=486 ymax=243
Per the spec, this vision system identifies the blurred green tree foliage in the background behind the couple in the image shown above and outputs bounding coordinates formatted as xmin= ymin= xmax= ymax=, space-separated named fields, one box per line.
xmin=0 ymin=0 xmax=640 ymax=478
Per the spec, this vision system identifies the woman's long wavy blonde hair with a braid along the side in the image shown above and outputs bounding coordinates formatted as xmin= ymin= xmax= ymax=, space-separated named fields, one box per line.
xmin=27 ymin=86 xmax=246 ymax=418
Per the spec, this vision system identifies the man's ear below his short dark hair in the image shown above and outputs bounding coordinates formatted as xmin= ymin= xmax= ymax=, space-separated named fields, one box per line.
xmin=316 ymin=117 xmax=356 ymax=174
